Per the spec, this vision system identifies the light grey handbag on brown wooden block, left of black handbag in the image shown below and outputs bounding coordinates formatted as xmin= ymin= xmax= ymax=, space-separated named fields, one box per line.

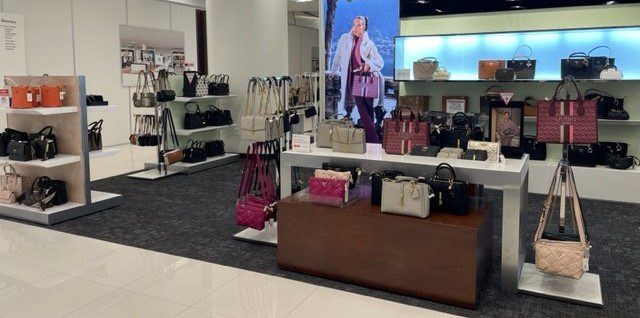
xmin=381 ymin=176 xmax=433 ymax=218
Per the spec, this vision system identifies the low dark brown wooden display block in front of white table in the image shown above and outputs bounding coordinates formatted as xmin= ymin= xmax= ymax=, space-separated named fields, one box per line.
xmin=278 ymin=188 xmax=493 ymax=308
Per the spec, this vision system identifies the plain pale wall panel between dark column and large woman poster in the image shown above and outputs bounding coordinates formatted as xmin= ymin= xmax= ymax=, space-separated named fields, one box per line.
xmin=207 ymin=0 xmax=289 ymax=152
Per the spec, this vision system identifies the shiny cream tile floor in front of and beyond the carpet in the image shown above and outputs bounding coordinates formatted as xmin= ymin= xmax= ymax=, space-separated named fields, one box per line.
xmin=0 ymin=146 xmax=460 ymax=318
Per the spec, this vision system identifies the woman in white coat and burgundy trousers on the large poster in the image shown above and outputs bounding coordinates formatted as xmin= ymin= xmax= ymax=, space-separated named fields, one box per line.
xmin=331 ymin=16 xmax=384 ymax=143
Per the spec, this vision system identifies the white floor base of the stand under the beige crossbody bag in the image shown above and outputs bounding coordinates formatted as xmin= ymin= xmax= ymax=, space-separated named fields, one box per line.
xmin=518 ymin=263 xmax=604 ymax=307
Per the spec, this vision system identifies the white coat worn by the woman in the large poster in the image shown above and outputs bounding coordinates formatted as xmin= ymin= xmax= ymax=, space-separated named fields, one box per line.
xmin=330 ymin=32 xmax=384 ymax=110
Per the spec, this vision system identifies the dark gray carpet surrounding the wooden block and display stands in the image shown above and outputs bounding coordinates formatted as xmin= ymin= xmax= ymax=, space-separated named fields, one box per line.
xmin=11 ymin=163 xmax=640 ymax=317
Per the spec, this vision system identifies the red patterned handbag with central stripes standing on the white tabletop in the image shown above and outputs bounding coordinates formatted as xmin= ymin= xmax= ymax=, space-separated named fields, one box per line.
xmin=382 ymin=107 xmax=430 ymax=155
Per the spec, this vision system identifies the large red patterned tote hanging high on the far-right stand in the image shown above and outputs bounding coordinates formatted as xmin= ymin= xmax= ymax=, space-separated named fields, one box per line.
xmin=536 ymin=77 xmax=598 ymax=144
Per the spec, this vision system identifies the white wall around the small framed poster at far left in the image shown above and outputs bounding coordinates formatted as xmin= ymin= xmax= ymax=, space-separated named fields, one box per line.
xmin=0 ymin=0 xmax=197 ymax=146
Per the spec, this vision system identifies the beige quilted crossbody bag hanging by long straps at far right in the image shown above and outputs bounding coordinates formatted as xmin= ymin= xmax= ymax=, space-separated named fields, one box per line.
xmin=533 ymin=162 xmax=591 ymax=279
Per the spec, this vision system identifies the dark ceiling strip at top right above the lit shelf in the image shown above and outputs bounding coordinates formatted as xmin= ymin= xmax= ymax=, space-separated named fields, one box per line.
xmin=400 ymin=0 xmax=640 ymax=18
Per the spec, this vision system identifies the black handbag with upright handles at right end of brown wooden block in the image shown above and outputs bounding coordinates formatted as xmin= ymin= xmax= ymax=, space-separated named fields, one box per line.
xmin=424 ymin=163 xmax=469 ymax=215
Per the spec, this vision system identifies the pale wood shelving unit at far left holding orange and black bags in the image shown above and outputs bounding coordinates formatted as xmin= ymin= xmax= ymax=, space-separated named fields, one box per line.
xmin=0 ymin=76 xmax=123 ymax=225
